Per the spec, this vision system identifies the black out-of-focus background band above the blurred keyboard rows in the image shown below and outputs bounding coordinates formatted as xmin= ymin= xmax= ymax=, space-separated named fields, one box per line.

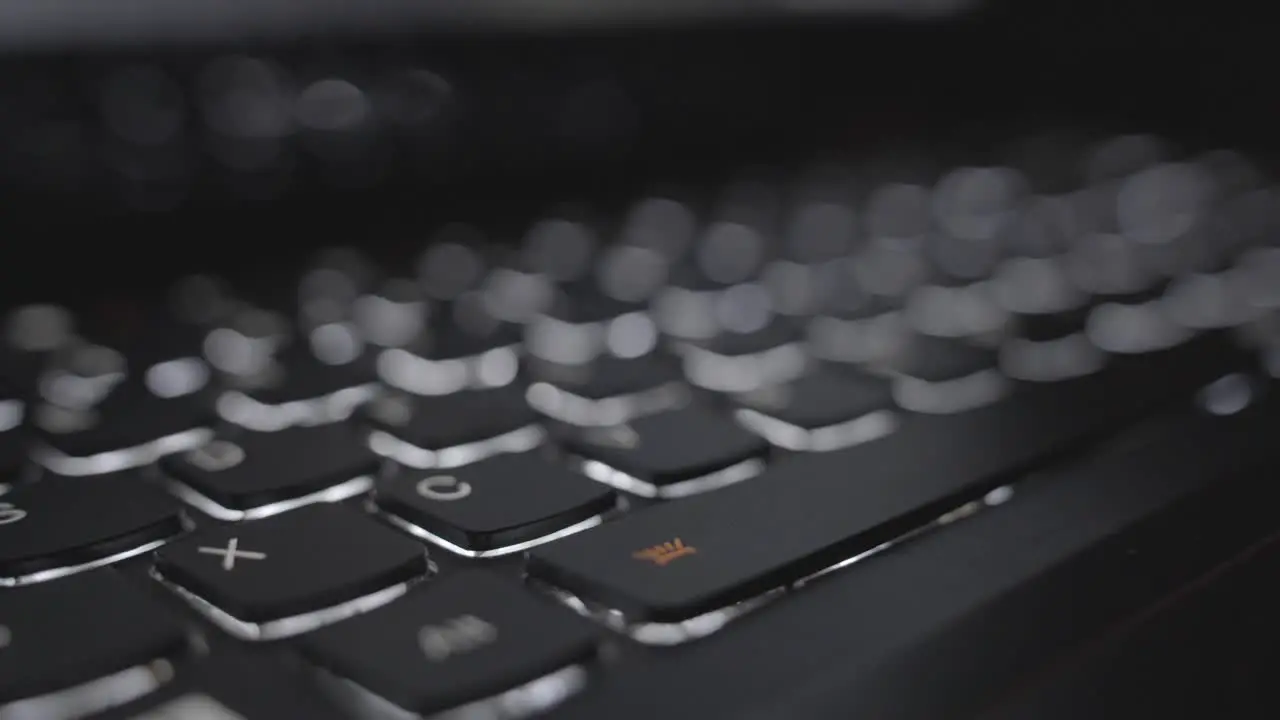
xmin=0 ymin=0 xmax=1276 ymax=299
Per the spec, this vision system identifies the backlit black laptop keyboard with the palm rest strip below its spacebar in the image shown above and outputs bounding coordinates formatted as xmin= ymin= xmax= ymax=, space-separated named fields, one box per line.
xmin=0 ymin=128 xmax=1280 ymax=720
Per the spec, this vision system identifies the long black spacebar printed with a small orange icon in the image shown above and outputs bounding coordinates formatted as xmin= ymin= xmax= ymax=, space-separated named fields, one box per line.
xmin=529 ymin=334 xmax=1244 ymax=623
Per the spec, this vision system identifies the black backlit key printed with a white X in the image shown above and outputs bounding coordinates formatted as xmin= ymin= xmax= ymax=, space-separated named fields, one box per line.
xmin=156 ymin=503 xmax=426 ymax=639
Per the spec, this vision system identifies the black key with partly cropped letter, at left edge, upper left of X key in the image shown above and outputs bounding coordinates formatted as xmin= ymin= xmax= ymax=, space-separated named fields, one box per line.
xmin=0 ymin=471 xmax=183 ymax=585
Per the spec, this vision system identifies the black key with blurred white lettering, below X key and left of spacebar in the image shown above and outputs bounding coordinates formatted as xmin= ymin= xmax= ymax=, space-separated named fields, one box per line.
xmin=302 ymin=571 xmax=596 ymax=714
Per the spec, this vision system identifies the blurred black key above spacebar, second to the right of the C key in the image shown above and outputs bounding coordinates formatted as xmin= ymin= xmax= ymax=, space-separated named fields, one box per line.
xmin=735 ymin=369 xmax=896 ymax=451
